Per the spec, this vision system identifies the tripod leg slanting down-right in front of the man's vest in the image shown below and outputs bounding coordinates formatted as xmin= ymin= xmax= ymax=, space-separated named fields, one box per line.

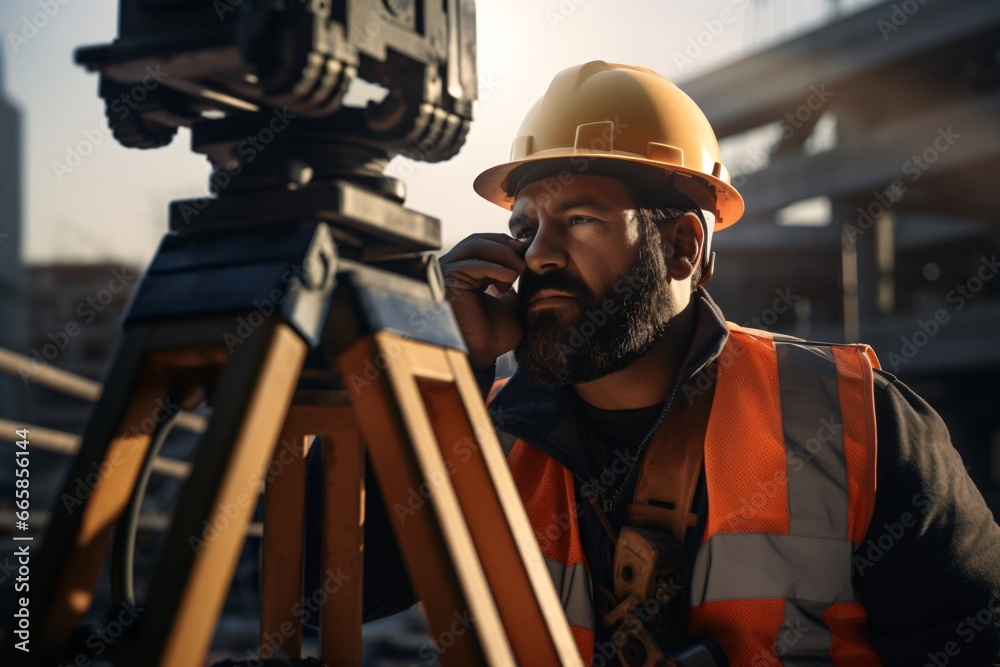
xmin=338 ymin=333 xmax=581 ymax=665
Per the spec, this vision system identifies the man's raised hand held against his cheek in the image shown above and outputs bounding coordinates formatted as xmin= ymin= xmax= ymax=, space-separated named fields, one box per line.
xmin=440 ymin=234 xmax=528 ymax=369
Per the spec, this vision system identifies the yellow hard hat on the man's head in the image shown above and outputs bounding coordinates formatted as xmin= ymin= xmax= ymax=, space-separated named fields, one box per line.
xmin=472 ymin=60 xmax=743 ymax=232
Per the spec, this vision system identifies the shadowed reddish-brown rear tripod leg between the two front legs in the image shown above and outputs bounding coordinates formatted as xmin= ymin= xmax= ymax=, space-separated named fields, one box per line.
xmin=261 ymin=402 xmax=365 ymax=667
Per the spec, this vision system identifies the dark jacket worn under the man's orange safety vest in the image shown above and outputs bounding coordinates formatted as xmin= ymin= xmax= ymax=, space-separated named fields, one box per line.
xmin=318 ymin=289 xmax=1000 ymax=667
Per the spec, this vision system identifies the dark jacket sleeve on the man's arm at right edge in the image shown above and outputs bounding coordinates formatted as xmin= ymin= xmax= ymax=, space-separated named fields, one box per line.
xmin=853 ymin=372 xmax=1000 ymax=667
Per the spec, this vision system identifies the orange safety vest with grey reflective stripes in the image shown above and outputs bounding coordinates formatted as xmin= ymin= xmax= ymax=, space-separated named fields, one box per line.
xmin=490 ymin=322 xmax=882 ymax=667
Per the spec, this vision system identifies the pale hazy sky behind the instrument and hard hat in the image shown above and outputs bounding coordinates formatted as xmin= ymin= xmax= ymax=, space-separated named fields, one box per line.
xmin=0 ymin=0 xmax=871 ymax=265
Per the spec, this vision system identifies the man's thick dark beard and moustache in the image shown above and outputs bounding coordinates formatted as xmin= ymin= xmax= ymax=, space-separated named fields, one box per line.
xmin=514 ymin=221 xmax=674 ymax=385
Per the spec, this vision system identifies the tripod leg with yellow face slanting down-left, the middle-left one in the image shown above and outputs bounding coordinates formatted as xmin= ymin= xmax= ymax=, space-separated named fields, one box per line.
xmin=116 ymin=321 xmax=308 ymax=667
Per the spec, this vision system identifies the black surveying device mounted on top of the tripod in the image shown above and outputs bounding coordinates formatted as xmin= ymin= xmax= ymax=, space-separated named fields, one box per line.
xmin=76 ymin=0 xmax=476 ymax=257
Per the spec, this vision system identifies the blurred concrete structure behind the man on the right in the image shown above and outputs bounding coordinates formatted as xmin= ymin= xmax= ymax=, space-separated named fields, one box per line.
xmin=696 ymin=0 xmax=1000 ymax=514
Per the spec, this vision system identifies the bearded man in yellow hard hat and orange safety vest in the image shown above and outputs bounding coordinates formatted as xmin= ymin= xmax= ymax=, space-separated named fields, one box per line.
xmin=348 ymin=62 xmax=1000 ymax=665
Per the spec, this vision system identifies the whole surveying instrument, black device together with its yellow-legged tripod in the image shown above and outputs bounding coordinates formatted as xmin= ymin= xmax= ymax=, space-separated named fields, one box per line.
xmin=0 ymin=0 xmax=581 ymax=667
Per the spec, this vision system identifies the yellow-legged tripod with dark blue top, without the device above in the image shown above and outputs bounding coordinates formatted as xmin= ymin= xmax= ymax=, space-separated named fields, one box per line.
xmin=2 ymin=126 xmax=580 ymax=667
